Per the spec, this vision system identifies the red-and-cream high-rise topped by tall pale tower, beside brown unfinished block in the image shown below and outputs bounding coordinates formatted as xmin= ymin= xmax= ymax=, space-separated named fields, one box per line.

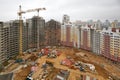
xmin=61 ymin=15 xmax=71 ymax=46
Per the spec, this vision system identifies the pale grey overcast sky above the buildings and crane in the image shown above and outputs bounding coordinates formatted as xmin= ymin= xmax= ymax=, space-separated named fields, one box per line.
xmin=0 ymin=0 xmax=120 ymax=21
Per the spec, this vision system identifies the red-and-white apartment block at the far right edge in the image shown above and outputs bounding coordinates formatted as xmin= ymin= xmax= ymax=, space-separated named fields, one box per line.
xmin=100 ymin=29 xmax=120 ymax=62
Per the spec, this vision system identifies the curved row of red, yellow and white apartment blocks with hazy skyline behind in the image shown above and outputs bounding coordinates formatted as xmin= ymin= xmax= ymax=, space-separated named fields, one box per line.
xmin=61 ymin=15 xmax=120 ymax=62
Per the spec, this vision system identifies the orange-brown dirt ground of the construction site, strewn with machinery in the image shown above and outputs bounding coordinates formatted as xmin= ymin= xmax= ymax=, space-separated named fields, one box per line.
xmin=1 ymin=46 xmax=120 ymax=80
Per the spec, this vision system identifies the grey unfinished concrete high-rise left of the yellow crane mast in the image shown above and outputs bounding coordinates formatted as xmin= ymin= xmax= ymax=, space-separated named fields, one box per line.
xmin=0 ymin=20 xmax=19 ymax=62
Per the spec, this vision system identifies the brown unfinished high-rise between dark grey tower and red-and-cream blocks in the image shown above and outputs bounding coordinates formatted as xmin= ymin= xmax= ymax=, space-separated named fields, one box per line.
xmin=45 ymin=19 xmax=61 ymax=46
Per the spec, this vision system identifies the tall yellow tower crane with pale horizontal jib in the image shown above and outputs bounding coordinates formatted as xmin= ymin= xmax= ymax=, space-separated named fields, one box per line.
xmin=18 ymin=5 xmax=46 ymax=55
